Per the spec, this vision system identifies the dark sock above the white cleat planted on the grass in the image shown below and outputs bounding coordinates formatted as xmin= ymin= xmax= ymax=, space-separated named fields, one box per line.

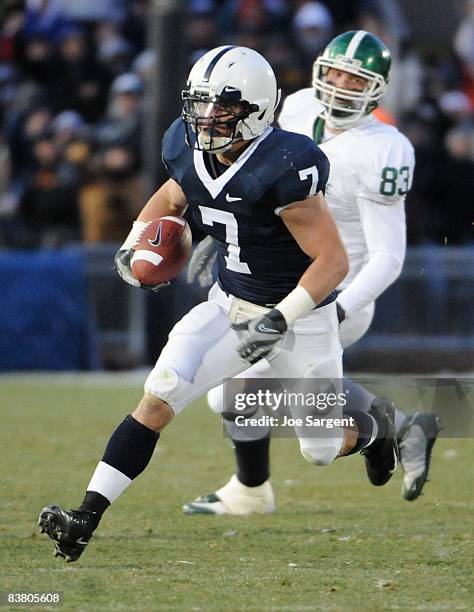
xmin=232 ymin=436 xmax=270 ymax=487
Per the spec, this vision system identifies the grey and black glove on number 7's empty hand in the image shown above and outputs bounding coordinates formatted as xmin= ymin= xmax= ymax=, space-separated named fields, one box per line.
xmin=232 ymin=308 xmax=288 ymax=363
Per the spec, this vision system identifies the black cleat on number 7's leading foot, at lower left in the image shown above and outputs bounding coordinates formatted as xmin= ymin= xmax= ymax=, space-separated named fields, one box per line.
xmin=38 ymin=506 xmax=98 ymax=563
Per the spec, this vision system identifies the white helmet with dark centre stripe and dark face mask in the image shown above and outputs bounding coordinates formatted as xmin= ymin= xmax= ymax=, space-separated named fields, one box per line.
xmin=182 ymin=46 xmax=280 ymax=153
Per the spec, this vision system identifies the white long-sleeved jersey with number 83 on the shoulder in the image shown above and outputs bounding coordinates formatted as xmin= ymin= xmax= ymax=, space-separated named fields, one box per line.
xmin=279 ymin=88 xmax=415 ymax=315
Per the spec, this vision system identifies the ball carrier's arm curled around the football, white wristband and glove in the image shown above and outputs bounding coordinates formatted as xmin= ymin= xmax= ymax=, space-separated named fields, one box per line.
xmin=115 ymin=178 xmax=187 ymax=290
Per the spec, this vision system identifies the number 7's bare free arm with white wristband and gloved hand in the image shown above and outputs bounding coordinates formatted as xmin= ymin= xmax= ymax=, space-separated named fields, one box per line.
xmin=233 ymin=192 xmax=349 ymax=363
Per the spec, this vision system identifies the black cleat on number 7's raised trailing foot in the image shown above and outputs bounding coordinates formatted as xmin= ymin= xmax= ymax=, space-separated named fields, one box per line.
xmin=360 ymin=397 xmax=399 ymax=487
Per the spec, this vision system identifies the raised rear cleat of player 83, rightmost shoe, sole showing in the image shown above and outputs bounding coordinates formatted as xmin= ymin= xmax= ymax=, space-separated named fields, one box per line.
xmin=398 ymin=412 xmax=442 ymax=501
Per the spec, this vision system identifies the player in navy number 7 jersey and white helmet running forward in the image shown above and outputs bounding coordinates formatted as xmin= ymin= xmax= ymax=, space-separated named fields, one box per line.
xmin=39 ymin=46 xmax=398 ymax=561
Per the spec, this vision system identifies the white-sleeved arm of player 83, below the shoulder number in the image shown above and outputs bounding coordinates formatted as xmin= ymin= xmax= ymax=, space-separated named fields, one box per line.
xmin=337 ymin=197 xmax=406 ymax=320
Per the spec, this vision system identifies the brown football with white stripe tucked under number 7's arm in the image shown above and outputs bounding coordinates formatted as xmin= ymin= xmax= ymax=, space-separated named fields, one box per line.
xmin=130 ymin=216 xmax=192 ymax=285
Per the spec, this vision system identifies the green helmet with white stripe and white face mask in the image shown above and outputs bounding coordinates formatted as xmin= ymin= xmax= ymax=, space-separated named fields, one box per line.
xmin=313 ymin=30 xmax=391 ymax=129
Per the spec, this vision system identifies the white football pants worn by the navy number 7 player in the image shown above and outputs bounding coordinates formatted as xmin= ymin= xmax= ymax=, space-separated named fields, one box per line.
xmin=145 ymin=284 xmax=343 ymax=465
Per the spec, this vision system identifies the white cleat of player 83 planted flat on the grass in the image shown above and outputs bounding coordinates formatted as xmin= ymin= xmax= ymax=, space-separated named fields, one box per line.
xmin=183 ymin=474 xmax=275 ymax=516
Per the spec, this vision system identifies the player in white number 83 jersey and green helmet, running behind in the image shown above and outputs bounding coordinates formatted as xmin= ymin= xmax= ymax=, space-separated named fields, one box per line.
xmin=183 ymin=30 xmax=439 ymax=514
